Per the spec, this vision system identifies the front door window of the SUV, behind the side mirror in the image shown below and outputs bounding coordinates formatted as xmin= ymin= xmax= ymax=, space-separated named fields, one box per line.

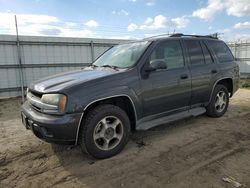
xmin=150 ymin=40 xmax=184 ymax=69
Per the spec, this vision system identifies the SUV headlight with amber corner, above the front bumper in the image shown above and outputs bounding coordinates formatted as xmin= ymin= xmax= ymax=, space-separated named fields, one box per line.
xmin=41 ymin=94 xmax=67 ymax=113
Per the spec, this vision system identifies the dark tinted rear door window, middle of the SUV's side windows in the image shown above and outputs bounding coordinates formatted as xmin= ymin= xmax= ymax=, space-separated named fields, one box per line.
xmin=185 ymin=40 xmax=205 ymax=65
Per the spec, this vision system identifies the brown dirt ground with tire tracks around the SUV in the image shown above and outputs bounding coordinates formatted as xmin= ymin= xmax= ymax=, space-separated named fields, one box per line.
xmin=0 ymin=89 xmax=250 ymax=188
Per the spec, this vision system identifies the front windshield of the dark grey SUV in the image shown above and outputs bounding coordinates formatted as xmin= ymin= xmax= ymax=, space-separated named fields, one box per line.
xmin=93 ymin=41 xmax=149 ymax=68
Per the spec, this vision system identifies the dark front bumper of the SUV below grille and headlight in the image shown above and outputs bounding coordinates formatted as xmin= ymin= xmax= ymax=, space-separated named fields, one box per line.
xmin=21 ymin=101 xmax=82 ymax=144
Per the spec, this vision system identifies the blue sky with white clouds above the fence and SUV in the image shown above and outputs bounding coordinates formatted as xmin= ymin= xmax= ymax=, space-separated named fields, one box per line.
xmin=0 ymin=0 xmax=250 ymax=41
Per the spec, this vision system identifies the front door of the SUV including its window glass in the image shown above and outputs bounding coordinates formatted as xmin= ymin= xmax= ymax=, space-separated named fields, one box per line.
xmin=141 ymin=40 xmax=191 ymax=117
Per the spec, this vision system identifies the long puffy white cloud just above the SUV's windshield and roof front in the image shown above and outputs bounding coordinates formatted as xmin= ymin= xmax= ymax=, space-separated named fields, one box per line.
xmin=128 ymin=14 xmax=189 ymax=31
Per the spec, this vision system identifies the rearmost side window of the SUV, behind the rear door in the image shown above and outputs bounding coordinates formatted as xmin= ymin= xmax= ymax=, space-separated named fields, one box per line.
xmin=208 ymin=41 xmax=234 ymax=63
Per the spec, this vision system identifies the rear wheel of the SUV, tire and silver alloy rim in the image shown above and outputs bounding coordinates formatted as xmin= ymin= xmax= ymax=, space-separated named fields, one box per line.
xmin=207 ymin=84 xmax=229 ymax=118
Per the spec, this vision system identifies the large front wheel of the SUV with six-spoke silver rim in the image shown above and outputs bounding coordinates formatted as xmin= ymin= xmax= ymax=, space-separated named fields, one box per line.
xmin=79 ymin=104 xmax=130 ymax=159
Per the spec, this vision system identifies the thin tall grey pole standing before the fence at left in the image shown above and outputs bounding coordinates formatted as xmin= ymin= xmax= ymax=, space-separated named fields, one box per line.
xmin=15 ymin=15 xmax=24 ymax=102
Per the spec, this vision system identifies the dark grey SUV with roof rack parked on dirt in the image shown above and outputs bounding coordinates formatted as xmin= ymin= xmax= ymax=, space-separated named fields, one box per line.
xmin=21 ymin=34 xmax=239 ymax=159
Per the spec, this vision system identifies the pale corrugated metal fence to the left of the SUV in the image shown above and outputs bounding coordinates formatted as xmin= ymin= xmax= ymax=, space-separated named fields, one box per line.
xmin=0 ymin=35 xmax=127 ymax=97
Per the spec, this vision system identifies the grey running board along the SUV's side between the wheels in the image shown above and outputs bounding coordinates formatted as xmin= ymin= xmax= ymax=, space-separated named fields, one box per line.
xmin=136 ymin=107 xmax=206 ymax=130
